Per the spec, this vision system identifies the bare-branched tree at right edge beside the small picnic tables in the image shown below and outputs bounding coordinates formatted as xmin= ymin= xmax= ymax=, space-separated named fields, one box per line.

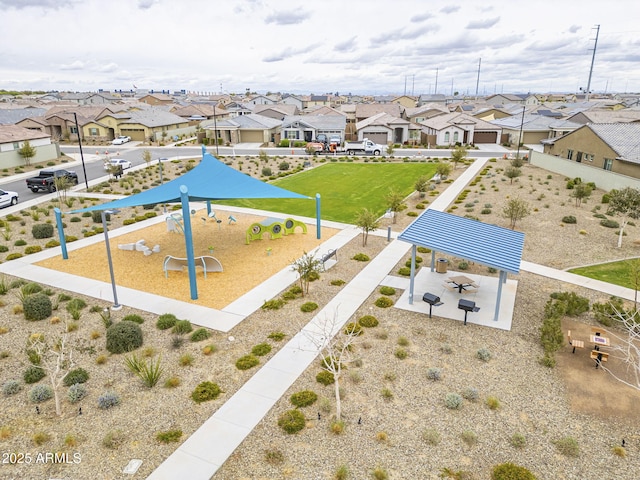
xmin=600 ymin=304 xmax=640 ymax=390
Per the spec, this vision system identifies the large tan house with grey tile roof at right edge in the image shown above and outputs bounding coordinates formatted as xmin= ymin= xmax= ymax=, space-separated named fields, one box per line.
xmin=544 ymin=122 xmax=640 ymax=179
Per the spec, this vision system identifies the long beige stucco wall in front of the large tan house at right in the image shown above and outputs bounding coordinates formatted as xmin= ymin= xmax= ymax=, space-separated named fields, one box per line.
xmin=529 ymin=150 xmax=640 ymax=191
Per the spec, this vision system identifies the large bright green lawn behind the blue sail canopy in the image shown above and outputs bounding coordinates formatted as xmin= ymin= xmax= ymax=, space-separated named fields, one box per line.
xmin=218 ymin=163 xmax=437 ymax=223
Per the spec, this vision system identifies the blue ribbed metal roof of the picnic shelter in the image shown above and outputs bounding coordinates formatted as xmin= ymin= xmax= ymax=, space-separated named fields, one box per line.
xmin=398 ymin=209 xmax=524 ymax=274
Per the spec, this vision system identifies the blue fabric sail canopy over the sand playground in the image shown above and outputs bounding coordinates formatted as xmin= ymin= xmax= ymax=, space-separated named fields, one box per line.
xmin=74 ymin=153 xmax=310 ymax=212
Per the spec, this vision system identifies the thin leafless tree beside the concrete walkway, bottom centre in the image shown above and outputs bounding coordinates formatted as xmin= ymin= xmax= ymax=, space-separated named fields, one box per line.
xmin=302 ymin=311 xmax=362 ymax=421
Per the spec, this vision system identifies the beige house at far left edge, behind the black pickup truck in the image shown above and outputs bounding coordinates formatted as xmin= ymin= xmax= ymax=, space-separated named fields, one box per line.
xmin=0 ymin=125 xmax=60 ymax=168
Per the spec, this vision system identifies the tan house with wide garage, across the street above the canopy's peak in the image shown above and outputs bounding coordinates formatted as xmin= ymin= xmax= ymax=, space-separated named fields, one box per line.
xmin=200 ymin=113 xmax=282 ymax=146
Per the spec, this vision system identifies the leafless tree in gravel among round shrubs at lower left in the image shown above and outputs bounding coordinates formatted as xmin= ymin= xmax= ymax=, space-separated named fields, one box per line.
xmin=28 ymin=330 xmax=75 ymax=416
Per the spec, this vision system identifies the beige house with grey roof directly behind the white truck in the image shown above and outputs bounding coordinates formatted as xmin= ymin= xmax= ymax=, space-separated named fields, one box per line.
xmin=356 ymin=112 xmax=412 ymax=145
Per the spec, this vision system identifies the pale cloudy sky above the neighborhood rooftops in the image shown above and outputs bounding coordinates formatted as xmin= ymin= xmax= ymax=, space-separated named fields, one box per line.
xmin=0 ymin=0 xmax=640 ymax=95
